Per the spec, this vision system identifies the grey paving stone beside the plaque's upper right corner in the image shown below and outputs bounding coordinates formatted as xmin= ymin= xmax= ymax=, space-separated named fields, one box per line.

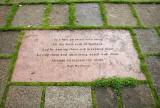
xmin=135 ymin=29 xmax=160 ymax=53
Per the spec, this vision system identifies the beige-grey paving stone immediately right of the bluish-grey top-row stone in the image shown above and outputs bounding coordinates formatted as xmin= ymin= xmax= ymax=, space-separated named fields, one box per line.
xmin=105 ymin=3 xmax=137 ymax=26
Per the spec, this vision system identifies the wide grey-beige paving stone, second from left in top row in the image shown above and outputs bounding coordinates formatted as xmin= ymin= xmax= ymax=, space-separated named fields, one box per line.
xmin=12 ymin=5 xmax=45 ymax=26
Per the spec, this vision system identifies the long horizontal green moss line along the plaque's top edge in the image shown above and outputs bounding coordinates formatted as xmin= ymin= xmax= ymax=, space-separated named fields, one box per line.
xmin=0 ymin=22 xmax=160 ymax=31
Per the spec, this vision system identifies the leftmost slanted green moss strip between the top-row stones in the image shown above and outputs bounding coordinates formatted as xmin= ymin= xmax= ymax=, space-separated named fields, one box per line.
xmin=5 ymin=4 xmax=18 ymax=28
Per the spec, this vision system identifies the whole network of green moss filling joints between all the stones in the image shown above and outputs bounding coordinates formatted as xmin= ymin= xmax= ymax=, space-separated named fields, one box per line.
xmin=0 ymin=0 xmax=160 ymax=108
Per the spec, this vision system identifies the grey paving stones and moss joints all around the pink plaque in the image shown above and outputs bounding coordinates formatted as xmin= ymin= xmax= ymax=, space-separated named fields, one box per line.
xmin=0 ymin=0 xmax=160 ymax=108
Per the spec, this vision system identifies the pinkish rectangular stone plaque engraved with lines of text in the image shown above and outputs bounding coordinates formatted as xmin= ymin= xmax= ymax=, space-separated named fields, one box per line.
xmin=12 ymin=30 xmax=145 ymax=82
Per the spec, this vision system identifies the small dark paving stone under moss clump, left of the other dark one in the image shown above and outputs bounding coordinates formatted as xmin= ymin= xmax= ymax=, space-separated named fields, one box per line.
xmin=96 ymin=88 xmax=118 ymax=108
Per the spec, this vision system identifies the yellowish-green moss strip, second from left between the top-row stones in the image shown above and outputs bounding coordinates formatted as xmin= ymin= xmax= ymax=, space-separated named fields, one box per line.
xmin=43 ymin=4 xmax=52 ymax=27
